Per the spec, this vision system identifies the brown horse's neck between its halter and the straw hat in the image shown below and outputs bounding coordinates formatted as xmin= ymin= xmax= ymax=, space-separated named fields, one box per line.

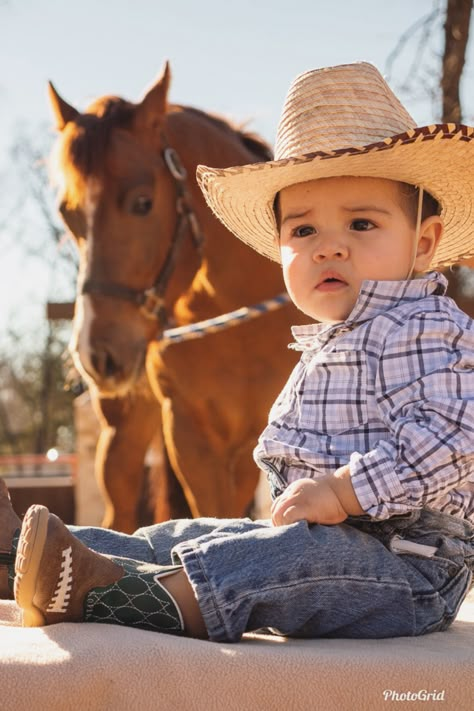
xmin=165 ymin=109 xmax=284 ymax=312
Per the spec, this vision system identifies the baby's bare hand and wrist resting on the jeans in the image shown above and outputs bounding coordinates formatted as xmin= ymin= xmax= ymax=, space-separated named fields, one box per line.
xmin=272 ymin=465 xmax=364 ymax=526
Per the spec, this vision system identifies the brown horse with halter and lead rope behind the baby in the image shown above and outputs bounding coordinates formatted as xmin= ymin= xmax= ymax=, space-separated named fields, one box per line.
xmin=51 ymin=65 xmax=300 ymax=530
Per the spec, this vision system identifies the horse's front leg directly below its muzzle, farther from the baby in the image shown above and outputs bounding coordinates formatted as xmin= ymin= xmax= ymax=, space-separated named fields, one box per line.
xmin=93 ymin=391 xmax=161 ymax=533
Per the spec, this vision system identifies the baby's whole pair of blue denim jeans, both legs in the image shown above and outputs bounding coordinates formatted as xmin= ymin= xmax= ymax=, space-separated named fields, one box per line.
xmin=70 ymin=510 xmax=474 ymax=642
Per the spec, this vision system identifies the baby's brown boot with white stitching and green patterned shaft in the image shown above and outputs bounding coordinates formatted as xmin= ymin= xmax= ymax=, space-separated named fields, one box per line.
xmin=15 ymin=505 xmax=184 ymax=634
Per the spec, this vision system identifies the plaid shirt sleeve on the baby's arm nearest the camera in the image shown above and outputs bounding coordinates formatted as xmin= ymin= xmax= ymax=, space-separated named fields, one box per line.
xmin=349 ymin=312 xmax=474 ymax=519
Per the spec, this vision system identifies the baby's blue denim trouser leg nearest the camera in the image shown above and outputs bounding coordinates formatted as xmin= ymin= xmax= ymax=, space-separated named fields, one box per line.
xmin=173 ymin=522 xmax=470 ymax=641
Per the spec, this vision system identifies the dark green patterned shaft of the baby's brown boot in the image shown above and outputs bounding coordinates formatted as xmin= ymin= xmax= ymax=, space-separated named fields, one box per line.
xmin=84 ymin=556 xmax=184 ymax=634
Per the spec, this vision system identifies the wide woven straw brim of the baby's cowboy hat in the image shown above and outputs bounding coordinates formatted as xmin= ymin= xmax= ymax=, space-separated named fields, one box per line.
xmin=197 ymin=124 xmax=474 ymax=268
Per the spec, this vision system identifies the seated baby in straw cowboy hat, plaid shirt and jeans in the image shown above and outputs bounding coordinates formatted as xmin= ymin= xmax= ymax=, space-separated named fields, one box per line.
xmin=0 ymin=63 xmax=474 ymax=641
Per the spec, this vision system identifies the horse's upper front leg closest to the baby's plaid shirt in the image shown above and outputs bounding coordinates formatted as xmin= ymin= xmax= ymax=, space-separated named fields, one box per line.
xmin=162 ymin=398 xmax=259 ymax=518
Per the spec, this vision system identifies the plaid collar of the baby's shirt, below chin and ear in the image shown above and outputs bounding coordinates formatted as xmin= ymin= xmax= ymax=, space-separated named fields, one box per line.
xmin=290 ymin=272 xmax=448 ymax=351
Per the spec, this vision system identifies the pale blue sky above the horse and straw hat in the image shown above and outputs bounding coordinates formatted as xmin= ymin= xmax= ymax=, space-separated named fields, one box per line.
xmin=0 ymin=0 xmax=474 ymax=347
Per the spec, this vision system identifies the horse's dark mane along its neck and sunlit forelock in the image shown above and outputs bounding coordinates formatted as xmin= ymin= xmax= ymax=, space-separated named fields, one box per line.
xmin=52 ymin=96 xmax=273 ymax=207
